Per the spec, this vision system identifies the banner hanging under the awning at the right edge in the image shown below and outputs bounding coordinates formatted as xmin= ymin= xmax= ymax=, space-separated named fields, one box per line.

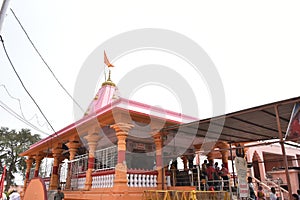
xmin=285 ymin=103 xmax=300 ymax=142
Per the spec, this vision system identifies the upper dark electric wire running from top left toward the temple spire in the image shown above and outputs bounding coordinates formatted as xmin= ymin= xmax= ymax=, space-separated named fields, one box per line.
xmin=10 ymin=8 xmax=84 ymax=113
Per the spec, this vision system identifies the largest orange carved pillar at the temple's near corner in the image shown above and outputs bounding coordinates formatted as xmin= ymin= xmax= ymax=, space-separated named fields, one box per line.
xmin=111 ymin=123 xmax=133 ymax=190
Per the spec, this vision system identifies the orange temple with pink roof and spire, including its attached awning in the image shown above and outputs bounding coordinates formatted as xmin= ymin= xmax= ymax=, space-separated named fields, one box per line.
xmin=21 ymin=52 xmax=300 ymax=200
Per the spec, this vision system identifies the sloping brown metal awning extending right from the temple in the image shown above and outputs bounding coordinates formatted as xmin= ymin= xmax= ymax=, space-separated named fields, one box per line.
xmin=162 ymin=97 xmax=300 ymax=143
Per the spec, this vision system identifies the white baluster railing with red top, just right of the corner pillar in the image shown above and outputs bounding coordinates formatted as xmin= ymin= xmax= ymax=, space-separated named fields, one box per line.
xmin=127 ymin=169 xmax=157 ymax=187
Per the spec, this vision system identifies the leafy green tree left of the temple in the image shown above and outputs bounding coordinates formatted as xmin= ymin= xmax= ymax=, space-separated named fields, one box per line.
xmin=0 ymin=127 xmax=41 ymax=191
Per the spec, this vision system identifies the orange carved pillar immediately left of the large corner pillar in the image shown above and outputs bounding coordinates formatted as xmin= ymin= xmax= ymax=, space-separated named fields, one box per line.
xmin=84 ymin=132 xmax=101 ymax=190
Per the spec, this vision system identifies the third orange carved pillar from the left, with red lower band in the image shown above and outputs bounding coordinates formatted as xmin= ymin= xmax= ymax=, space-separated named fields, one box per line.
xmin=49 ymin=147 xmax=63 ymax=190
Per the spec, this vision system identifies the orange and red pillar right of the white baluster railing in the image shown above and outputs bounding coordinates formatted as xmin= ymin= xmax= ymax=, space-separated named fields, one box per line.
xmin=152 ymin=132 xmax=167 ymax=190
